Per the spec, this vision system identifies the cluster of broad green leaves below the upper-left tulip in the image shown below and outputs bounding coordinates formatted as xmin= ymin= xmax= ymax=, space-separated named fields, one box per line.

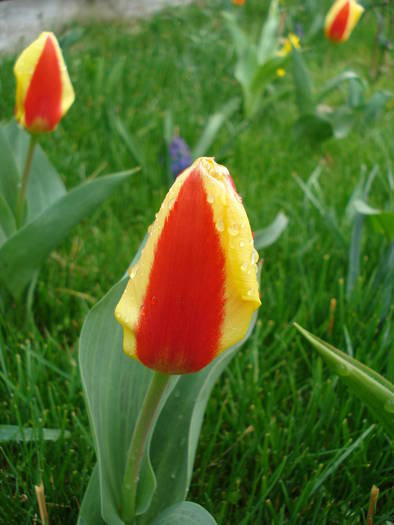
xmin=0 ymin=125 xmax=137 ymax=299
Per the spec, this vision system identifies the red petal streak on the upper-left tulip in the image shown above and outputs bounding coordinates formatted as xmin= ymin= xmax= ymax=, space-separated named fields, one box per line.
xmin=25 ymin=37 xmax=62 ymax=131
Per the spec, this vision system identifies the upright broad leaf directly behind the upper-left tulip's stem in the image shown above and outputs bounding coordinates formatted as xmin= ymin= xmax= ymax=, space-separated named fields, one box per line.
xmin=3 ymin=122 xmax=66 ymax=222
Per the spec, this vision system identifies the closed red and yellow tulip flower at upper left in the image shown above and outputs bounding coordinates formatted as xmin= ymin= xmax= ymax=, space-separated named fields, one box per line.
xmin=14 ymin=33 xmax=74 ymax=133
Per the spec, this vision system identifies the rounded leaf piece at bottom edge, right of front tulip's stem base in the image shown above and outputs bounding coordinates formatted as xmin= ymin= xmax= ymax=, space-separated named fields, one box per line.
xmin=151 ymin=501 xmax=217 ymax=525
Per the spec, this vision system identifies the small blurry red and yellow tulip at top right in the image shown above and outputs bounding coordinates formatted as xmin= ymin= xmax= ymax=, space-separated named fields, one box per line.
xmin=324 ymin=0 xmax=364 ymax=42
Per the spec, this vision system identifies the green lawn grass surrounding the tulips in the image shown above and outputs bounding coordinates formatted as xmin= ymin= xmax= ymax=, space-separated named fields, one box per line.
xmin=0 ymin=2 xmax=394 ymax=525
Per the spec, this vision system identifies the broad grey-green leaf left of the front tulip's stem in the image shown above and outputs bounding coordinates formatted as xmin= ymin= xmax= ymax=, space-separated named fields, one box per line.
xmin=79 ymin=277 xmax=177 ymax=525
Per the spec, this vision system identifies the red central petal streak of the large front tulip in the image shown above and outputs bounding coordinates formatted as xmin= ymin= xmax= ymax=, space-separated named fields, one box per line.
xmin=136 ymin=170 xmax=225 ymax=374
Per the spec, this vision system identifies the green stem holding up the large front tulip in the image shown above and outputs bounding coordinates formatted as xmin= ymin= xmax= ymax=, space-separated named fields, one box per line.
xmin=121 ymin=372 xmax=171 ymax=525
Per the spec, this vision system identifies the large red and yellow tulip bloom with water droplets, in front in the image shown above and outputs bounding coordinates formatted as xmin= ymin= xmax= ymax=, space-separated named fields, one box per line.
xmin=115 ymin=158 xmax=261 ymax=374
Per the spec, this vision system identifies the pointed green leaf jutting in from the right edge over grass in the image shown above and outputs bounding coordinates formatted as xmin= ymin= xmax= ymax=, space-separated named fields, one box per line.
xmin=294 ymin=323 xmax=394 ymax=437
